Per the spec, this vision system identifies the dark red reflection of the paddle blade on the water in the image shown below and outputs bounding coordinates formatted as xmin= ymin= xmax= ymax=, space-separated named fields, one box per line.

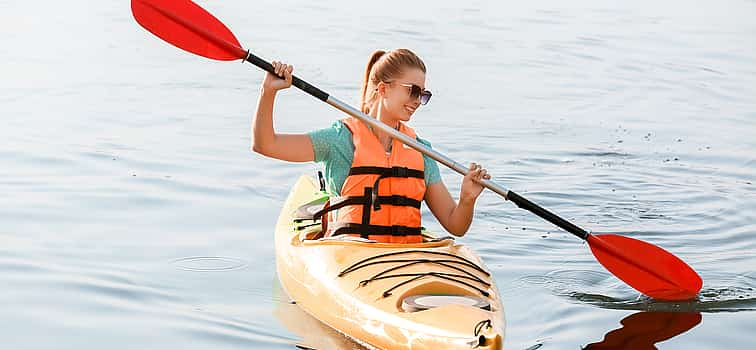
xmin=583 ymin=311 xmax=701 ymax=350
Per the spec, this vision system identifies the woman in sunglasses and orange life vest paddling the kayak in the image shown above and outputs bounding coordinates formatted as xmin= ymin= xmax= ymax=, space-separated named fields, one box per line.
xmin=252 ymin=49 xmax=490 ymax=243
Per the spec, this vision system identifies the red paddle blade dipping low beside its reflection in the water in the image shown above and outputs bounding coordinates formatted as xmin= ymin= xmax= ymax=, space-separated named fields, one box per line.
xmin=588 ymin=234 xmax=703 ymax=300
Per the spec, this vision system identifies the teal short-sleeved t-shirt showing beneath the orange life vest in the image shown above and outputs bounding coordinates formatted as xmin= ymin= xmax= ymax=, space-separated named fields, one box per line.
xmin=309 ymin=120 xmax=441 ymax=196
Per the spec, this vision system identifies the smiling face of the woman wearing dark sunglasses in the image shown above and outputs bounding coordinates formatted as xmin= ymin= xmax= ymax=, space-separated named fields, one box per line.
xmin=379 ymin=68 xmax=425 ymax=122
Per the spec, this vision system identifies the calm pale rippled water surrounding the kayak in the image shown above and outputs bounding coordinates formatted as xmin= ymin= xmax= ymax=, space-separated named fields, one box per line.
xmin=0 ymin=0 xmax=756 ymax=349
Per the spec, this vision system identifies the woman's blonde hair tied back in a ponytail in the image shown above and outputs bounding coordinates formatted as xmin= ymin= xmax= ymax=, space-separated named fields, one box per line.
xmin=360 ymin=49 xmax=426 ymax=113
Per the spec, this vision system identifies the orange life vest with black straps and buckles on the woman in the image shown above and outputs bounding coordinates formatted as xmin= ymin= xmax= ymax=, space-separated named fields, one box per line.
xmin=323 ymin=117 xmax=425 ymax=243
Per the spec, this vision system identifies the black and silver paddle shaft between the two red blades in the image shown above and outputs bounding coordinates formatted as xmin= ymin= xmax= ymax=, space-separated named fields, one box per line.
xmin=244 ymin=52 xmax=589 ymax=240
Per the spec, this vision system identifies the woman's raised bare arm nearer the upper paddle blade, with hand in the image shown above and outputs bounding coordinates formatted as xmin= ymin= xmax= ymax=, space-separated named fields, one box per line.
xmin=252 ymin=61 xmax=315 ymax=162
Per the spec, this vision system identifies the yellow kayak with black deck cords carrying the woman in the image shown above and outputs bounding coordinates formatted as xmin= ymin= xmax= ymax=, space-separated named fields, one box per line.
xmin=275 ymin=176 xmax=505 ymax=350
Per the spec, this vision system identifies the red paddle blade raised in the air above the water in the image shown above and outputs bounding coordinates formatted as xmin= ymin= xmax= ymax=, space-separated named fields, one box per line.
xmin=131 ymin=0 xmax=247 ymax=61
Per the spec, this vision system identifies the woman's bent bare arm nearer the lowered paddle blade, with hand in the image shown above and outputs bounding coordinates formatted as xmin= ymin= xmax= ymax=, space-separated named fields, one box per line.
xmin=425 ymin=163 xmax=491 ymax=237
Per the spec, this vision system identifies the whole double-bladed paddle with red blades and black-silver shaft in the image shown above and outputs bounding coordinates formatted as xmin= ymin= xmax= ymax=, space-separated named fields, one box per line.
xmin=131 ymin=0 xmax=703 ymax=300
